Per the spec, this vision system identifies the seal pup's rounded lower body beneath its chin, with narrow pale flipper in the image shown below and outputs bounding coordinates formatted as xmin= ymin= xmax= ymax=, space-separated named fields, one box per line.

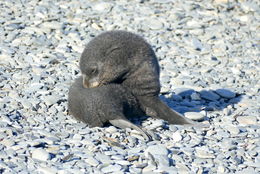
xmin=68 ymin=77 xmax=151 ymax=140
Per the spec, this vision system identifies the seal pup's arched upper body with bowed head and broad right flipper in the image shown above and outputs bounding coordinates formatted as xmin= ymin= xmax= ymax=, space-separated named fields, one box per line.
xmin=80 ymin=30 xmax=194 ymax=125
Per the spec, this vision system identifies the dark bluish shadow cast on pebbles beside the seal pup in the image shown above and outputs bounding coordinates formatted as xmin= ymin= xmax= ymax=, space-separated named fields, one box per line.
xmin=160 ymin=89 xmax=243 ymax=114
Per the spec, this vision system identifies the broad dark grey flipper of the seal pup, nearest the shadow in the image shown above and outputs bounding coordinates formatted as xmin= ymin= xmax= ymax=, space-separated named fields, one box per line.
xmin=138 ymin=96 xmax=196 ymax=125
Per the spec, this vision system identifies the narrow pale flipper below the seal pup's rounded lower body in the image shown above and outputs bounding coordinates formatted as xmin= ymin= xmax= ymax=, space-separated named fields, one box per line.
xmin=109 ymin=119 xmax=152 ymax=140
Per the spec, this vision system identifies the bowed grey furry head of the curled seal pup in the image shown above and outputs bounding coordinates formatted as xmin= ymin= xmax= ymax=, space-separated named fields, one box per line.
xmin=79 ymin=31 xmax=135 ymax=88
